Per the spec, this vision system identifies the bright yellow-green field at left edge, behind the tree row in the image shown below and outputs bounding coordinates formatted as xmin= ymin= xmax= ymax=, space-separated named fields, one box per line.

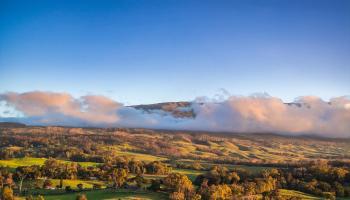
xmin=0 ymin=157 xmax=97 ymax=168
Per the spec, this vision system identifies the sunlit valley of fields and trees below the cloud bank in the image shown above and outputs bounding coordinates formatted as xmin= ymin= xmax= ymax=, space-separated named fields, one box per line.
xmin=0 ymin=127 xmax=350 ymax=199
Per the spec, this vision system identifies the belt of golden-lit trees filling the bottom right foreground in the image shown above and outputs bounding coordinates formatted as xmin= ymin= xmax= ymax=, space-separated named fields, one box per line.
xmin=163 ymin=161 xmax=350 ymax=200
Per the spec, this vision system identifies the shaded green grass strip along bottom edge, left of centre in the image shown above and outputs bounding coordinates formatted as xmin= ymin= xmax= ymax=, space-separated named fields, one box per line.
xmin=44 ymin=190 xmax=168 ymax=200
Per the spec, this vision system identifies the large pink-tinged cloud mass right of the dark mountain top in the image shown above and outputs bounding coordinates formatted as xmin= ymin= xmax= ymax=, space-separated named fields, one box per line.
xmin=189 ymin=96 xmax=350 ymax=137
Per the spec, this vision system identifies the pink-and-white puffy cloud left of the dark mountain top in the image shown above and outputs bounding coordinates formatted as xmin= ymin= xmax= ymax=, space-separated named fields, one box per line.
xmin=0 ymin=92 xmax=122 ymax=124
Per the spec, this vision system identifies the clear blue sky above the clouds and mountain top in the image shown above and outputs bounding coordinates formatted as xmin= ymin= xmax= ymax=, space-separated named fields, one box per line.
xmin=0 ymin=0 xmax=350 ymax=104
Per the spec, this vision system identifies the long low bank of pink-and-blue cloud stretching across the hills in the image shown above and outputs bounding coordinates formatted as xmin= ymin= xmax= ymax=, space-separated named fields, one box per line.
xmin=0 ymin=92 xmax=350 ymax=137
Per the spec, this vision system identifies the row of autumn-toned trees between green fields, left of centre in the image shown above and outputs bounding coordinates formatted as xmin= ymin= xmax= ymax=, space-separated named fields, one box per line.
xmin=18 ymin=157 xmax=171 ymax=187
